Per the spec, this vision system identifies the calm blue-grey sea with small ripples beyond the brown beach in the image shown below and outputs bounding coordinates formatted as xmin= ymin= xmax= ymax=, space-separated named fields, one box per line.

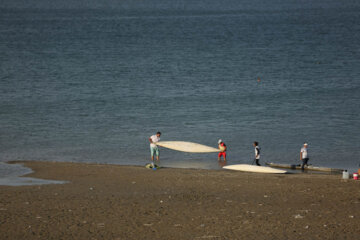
xmin=0 ymin=0 xmax=360 ymax=174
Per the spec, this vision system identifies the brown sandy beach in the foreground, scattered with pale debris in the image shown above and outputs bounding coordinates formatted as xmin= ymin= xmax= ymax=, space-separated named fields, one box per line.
xmin=0 ymin=162 xmax=360 ymax=240
